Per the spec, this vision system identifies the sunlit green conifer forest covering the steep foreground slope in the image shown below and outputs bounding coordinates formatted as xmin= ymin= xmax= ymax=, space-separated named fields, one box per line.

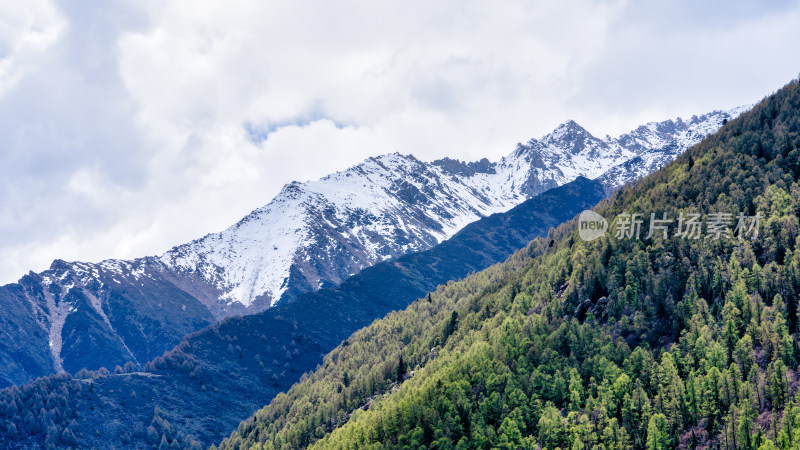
xmin=221 ymin=81 xmax=800 ymax=449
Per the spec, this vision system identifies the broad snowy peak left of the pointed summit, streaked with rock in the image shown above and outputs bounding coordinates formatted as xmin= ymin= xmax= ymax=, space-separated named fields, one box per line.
xmin=161 ymin=149 xmax=513 ymax=308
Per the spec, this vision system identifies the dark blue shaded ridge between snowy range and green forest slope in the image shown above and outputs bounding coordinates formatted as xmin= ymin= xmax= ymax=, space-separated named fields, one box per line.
xmin=0 ymin=178 xmax=604 ymax=448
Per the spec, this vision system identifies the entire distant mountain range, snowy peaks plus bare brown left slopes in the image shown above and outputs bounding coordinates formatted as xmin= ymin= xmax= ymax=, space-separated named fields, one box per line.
xmin=0 ymin=108 xmax=746 ymax=387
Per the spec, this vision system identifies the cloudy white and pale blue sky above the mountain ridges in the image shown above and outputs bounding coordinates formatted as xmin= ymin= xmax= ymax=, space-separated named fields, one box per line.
xmin=0 ymin=0 xmax=800 ymax=283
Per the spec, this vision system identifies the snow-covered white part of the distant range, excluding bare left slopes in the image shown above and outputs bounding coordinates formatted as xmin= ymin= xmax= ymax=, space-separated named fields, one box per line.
xmin=160 ymin=107 xmax=746 ymax=311
